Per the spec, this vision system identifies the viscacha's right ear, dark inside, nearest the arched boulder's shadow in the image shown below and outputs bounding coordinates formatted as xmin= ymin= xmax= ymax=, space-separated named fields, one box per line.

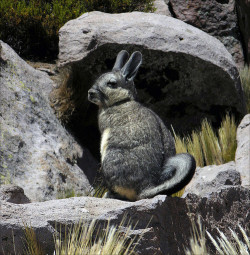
xmin=121 ymin=51 xmax=142 ymax=81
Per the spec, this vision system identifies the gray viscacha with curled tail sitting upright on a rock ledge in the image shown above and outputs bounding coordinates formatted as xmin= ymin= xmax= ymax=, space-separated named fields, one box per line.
xmin=89 ymin=51 xmax=196 ymax=201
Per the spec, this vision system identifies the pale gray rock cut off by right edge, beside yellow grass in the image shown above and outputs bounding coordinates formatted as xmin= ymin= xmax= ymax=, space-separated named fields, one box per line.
xmin=235 ymin=114 xmax=250 ymax=188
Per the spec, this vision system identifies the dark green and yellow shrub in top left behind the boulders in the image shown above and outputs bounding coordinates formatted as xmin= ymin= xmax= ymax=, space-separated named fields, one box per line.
xmin=0 ymin=0 xmax=154 ymax=61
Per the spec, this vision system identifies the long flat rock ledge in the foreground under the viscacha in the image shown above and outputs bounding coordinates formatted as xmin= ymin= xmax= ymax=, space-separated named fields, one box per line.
xmin=0 ymin=187 xmax=250 ymax=255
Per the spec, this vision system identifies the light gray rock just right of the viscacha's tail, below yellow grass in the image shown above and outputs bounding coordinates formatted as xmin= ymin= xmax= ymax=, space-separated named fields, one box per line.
xmin=183 ymin=161 xmax=241 ymax=197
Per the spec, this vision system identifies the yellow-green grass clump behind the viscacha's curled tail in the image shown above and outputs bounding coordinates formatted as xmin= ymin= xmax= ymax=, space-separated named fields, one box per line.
xmin=174 ymin=114 xmax=237 ymax=167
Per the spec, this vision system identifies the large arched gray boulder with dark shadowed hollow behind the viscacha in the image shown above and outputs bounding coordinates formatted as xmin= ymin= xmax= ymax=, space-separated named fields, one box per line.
xmin=54 ymin=12 xmax=245 ymax=158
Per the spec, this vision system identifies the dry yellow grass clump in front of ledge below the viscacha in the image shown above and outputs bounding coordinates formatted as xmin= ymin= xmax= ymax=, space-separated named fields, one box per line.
xmin=54 ymin=218 xmax=141 ymax=255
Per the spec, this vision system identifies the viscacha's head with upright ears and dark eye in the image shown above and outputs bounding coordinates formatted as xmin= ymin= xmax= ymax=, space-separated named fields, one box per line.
xmin=88 ymin=50 xmax=142 ymax=107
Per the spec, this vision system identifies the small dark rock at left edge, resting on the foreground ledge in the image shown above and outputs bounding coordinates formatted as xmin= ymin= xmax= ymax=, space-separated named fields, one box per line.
xmin=0 ymin=184 xmax=30 ymax=204
